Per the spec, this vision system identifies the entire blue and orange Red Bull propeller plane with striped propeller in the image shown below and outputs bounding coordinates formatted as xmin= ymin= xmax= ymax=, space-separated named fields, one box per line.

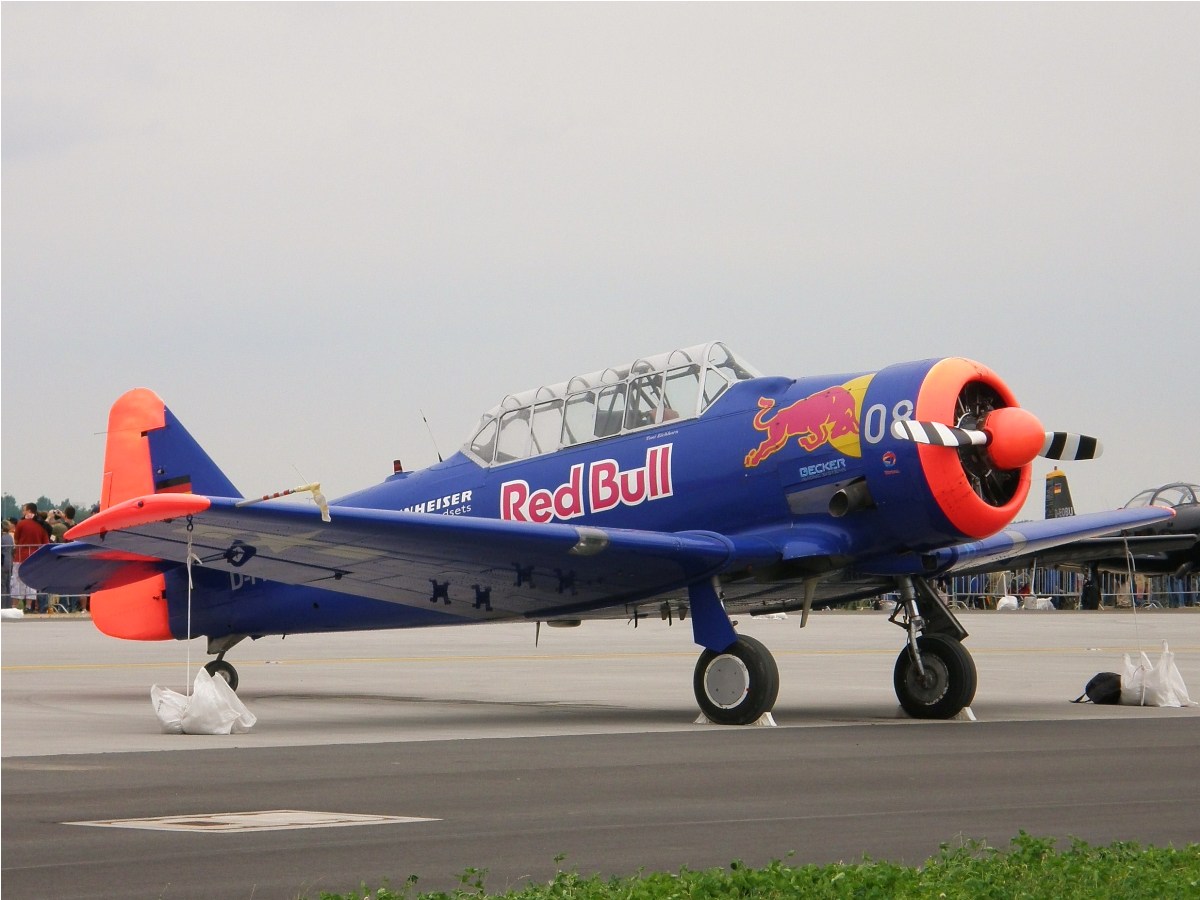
xmin=22 ymin=342 xmax=1172 ymax=725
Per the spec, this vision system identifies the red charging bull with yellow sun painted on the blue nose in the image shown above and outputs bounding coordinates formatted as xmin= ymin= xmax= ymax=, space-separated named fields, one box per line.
xmin=745 ymin=383 xmax=866 ymax=468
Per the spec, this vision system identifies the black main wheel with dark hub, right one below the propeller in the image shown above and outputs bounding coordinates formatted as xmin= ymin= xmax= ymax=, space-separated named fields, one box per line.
xmin=893 ymin=635 xmax=978 ymax=719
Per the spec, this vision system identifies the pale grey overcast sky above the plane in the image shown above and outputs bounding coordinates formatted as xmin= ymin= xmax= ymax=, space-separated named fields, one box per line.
xmin=0 ymin=2 xmax=1200 ymax=517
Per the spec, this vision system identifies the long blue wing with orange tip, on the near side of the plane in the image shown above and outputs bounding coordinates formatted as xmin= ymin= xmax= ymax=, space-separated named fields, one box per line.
xmin=22 ymin=494 xmax=734 ymax=618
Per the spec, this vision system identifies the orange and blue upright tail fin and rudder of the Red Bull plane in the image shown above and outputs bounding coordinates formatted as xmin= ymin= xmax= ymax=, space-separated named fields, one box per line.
xmin=91 ymin=388 xmax=241 ymax=641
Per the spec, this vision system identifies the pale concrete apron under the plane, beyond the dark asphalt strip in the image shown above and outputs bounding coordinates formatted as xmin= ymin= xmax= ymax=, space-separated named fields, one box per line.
xmin=0 ymin=608 xmax=1200 ymax=757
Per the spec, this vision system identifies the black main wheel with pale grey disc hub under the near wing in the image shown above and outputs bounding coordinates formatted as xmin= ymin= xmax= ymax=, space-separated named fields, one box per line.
xmin=692 ymin=635 xmax=779 ymax=725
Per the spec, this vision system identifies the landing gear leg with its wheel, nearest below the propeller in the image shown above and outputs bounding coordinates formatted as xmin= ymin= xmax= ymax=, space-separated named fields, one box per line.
xmin=889 ymin=578 xmax=978 ymax=719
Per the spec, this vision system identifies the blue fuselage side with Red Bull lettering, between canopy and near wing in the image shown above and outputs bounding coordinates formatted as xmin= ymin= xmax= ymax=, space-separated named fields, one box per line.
xmin=334 ymin=360 xmax=1024 ymax=566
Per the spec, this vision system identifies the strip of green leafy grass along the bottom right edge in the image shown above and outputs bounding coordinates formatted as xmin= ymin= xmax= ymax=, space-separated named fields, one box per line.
xmin=320 ymin=832 xmax=1200 ymax=900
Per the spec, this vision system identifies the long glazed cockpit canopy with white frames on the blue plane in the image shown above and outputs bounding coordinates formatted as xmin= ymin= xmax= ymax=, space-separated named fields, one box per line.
xmin=463 ymin=341 xmax=760 ymax=466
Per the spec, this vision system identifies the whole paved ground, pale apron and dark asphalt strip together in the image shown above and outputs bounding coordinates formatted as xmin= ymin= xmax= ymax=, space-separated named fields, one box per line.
xmin=0 ymin=611 xmax=1200 ymax=899
